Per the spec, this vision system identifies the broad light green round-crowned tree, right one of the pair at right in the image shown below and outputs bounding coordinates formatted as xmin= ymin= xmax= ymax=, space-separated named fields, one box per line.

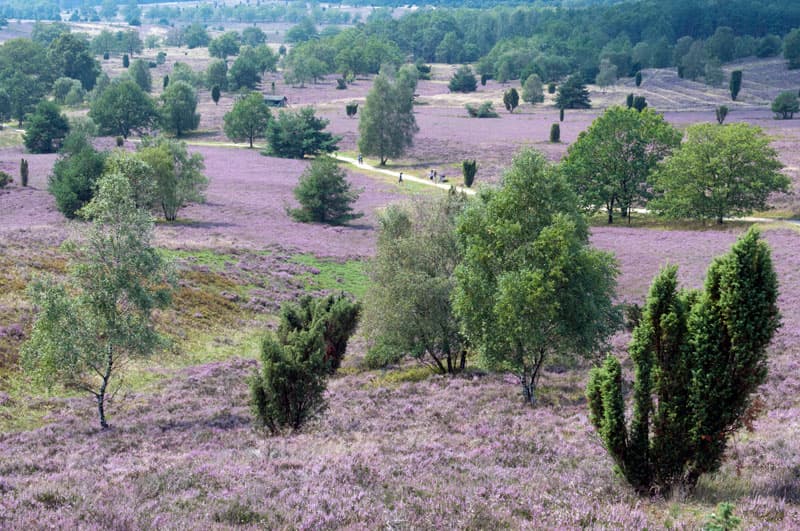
xmin=651 ymin=123 xmax=790 ymax=223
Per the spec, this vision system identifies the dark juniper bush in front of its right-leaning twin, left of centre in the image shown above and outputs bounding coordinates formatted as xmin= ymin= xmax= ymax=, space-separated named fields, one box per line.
xmin=250 ymin=325 xmax=328 ymax=435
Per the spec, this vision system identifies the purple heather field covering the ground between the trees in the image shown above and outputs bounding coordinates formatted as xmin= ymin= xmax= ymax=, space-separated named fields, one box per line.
xmin=0 ymin=26 xmax=800 ymax=530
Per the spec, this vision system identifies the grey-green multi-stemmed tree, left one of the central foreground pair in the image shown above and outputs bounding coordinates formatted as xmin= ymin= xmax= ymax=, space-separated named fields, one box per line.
xmin=364 ymin=193 xmax=467 ymax=374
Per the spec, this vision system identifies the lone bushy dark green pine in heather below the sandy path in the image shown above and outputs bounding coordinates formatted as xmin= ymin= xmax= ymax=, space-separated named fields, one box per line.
xmin=288 ymin=157 xmax=364 ymax=225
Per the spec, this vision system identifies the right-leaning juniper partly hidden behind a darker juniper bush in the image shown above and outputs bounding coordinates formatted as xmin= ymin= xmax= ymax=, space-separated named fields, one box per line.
xmin=276 ymin=295 xmax=361 ymax=374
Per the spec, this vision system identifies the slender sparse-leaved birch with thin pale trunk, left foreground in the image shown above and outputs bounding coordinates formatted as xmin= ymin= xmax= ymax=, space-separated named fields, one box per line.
xmin=21 ymin=174 xmax=171 ymax=429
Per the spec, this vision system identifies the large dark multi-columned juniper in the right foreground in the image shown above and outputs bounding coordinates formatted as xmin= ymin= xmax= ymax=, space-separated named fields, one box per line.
xmin=586 ymin=229 xmax=780 ymax=493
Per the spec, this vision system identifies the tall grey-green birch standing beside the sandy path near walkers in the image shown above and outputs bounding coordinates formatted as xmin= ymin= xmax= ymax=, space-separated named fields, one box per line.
xmin=358 ymin=74 xmax=419 ymax=166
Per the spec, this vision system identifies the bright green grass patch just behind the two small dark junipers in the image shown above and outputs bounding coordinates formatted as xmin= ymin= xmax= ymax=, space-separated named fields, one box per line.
xmin=291 ymin=254 xmax=369 ymax=299
